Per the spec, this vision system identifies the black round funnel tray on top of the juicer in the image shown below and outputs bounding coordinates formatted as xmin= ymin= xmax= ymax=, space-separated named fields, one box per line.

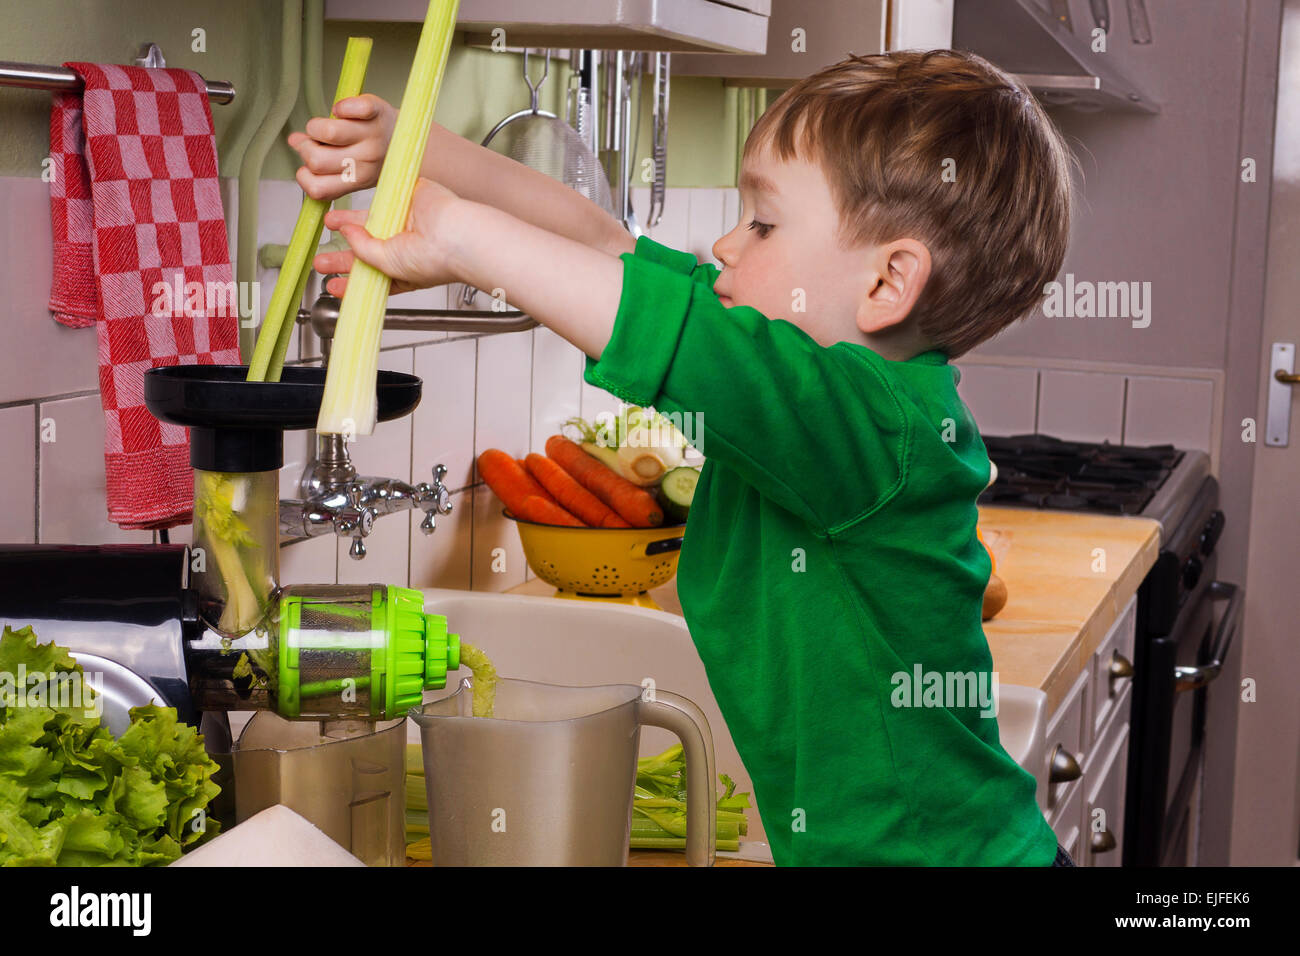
xmin=144 ymin=365 xmax=421 ymax=472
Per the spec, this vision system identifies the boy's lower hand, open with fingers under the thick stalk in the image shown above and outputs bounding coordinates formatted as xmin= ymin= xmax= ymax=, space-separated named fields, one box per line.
xmin=312 ymin=178 xmax=463 ymax=295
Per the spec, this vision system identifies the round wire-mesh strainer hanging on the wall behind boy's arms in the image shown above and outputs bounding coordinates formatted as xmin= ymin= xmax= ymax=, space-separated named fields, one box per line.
xmin=451 ymin=49 xmax=615 ymax=308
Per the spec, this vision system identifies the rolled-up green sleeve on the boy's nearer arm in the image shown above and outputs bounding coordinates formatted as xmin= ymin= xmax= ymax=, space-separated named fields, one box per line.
xmin=585 ymin=237 xmax=911 ymax=532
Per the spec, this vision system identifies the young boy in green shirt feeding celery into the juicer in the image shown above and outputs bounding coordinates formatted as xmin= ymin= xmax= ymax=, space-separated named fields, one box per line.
xmin=290 ymin=51 xmax=1073 ymax=866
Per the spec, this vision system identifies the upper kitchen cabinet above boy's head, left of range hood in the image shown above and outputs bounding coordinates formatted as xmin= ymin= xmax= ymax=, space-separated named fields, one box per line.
xmin=672 ymin=0 xmax=953 ymax=87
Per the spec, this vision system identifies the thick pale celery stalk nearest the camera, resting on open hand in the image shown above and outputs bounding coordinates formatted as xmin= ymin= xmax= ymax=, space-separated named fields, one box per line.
xmin=316 ymin=0 xmax=459 ymax=437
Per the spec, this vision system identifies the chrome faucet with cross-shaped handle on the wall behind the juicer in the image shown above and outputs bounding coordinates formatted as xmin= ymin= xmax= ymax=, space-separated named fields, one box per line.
xmin=280 ymin=434 xmax=451 ymax=561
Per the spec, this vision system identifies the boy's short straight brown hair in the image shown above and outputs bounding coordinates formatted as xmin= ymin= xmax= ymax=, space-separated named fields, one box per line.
xmin=745 ymin=49 xmax=1073 ymax=358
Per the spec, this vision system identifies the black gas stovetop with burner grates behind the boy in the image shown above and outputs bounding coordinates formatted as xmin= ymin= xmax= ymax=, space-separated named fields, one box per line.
xmin=979 ymin=433 xmax=1209 ymax=535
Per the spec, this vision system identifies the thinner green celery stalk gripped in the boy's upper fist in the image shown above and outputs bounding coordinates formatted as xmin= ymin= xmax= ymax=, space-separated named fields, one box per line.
xmin=247 ymin=36 xmax=373 ymax=381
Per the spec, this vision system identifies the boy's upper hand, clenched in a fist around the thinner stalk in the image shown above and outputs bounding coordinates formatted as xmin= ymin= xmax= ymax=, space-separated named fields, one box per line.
xmin=289 ymin=92 xmax=398 ymax=199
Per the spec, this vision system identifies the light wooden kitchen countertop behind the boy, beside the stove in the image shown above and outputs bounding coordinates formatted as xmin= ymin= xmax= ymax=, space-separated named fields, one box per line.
xmin=508 ymin=507 xmax=1160 ymax=714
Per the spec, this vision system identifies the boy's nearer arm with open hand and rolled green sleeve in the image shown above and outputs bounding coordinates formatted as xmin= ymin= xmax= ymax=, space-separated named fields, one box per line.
xmin=335 ymin=193 xmax=910 ymax=531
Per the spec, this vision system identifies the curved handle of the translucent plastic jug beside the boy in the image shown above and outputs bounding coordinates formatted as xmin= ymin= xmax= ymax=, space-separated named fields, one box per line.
xmin=637 ymin=688 xmax=718 ymax=866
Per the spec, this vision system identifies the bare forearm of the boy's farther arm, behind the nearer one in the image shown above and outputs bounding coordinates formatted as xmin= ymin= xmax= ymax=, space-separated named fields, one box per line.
xmin=420 ymin=122 xmax=636 ymax=260
